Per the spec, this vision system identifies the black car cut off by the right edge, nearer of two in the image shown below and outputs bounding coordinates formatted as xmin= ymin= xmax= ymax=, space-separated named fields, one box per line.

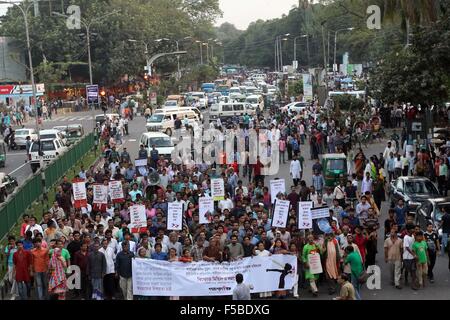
xmin=416 ymin=197 xmax=450 ymax=230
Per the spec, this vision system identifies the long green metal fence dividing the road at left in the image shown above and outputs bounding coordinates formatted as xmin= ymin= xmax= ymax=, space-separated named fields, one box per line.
xmin=0 ymin=133 xmax=94 ymax=239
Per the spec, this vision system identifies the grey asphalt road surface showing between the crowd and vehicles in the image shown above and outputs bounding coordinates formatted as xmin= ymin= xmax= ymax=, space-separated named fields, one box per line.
xmin=4 ymin=108 xmax=450 ymax=300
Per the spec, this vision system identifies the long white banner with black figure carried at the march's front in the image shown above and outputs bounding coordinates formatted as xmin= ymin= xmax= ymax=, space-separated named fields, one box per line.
xmin=132 ymin=254 xmax=298 ymax=297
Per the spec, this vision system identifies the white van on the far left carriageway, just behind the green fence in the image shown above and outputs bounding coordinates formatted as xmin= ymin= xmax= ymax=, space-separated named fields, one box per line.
xmin=28 ymin=139 xmax=67 ymax=173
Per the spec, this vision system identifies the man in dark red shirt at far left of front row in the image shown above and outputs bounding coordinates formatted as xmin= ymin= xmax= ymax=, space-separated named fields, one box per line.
xmin=13 ymin=240 xmax=32 ymax=300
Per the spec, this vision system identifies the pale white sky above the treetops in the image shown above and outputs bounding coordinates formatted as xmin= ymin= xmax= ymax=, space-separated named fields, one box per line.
xmin=216 ymin=0 xmax=298 ymax=30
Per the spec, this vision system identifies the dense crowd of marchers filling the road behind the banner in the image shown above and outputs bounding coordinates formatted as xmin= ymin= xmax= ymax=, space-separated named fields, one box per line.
xmin=5 ymin=100 xmax=450 ymax=300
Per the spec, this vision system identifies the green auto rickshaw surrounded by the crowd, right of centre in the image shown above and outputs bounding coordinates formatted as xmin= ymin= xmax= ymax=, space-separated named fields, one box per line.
xmin=322 ymin=153 xmax=348 ymax=187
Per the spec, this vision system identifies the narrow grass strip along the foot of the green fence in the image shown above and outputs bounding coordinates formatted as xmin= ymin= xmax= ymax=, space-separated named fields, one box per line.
xmin=0 ymin=146 xmax=101 ymax=286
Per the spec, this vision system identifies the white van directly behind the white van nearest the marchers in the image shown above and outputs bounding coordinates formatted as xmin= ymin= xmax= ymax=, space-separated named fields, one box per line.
xmin=145 ymin=108 xmax=201 ymax=136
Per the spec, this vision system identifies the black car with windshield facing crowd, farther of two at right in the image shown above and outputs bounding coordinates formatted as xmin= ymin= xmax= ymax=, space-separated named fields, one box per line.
xmin=389 ymin=177 xmax=441 ymax=215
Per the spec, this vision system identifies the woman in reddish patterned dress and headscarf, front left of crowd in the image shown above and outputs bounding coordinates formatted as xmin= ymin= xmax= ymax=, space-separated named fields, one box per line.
xmin=48 ymin=248 xmax=67 ymax=300
